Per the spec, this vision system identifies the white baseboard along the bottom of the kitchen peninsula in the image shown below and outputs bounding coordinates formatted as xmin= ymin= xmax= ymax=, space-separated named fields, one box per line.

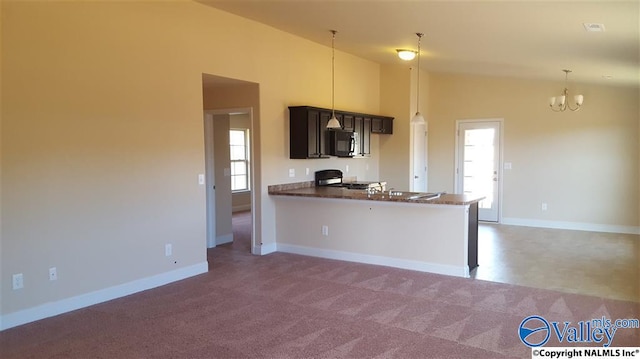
xmin=277 ymin=243 xmax=469 ymax=278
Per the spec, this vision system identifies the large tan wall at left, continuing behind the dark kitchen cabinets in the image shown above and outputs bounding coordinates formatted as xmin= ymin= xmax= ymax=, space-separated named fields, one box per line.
xmin=0 ymin=2 xmax=380 ymax=324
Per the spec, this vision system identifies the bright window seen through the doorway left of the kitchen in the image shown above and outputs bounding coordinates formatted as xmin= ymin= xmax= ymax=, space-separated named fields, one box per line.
xmin=229 ymin=129 xmax=250 ymax=192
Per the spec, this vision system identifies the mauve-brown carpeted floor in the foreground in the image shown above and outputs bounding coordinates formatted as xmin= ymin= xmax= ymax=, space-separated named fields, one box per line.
xmin=0 ymin=211 xmax=640 ymax=359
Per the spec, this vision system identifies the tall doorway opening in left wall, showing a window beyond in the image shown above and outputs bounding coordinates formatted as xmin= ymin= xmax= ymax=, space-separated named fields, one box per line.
xmin=202 ymin=74 xmax=262 ymax=254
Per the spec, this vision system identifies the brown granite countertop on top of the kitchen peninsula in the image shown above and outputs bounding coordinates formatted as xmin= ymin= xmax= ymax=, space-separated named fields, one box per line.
xmin=268 ymin=181 xmax=484 ymax=206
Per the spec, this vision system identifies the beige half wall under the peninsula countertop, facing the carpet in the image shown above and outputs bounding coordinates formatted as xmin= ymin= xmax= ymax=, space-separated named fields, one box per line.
xmin=275 ymin=196 xmax=469 ymax=276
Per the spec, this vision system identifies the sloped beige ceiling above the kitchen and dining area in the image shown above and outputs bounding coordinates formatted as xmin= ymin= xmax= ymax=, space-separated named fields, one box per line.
xmin=197 ymin=0 xmax=640 ymax=86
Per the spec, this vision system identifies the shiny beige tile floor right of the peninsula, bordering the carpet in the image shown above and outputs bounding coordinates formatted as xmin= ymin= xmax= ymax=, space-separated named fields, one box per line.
xmin=471 ymin=223 xmax=640 ymax=302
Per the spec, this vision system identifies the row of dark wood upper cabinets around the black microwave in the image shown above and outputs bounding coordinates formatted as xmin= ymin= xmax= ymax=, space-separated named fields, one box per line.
xmin=289 ymin=106 xmax=393 ymax=159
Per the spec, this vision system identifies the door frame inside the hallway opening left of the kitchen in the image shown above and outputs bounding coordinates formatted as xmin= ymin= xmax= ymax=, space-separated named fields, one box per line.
xmin=204 ymin=107 xmax=255 ymax=254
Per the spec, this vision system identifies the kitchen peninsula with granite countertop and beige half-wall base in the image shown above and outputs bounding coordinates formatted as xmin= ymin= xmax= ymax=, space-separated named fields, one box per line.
xmin=268 ymin=181 xmax=483 ymax=277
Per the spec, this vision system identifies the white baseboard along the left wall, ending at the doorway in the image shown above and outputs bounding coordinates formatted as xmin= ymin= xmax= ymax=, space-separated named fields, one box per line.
xmin=0 ymin=261 xmax=209 ymax=331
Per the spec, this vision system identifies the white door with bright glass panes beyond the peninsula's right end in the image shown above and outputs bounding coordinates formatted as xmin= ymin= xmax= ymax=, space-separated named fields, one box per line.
xmin=456 ymin=121 xmax=501 ymax=222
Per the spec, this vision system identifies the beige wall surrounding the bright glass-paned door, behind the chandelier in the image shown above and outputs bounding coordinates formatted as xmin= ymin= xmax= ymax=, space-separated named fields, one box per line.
xmin=428 ymin=73 xmax=640 ymax=230
